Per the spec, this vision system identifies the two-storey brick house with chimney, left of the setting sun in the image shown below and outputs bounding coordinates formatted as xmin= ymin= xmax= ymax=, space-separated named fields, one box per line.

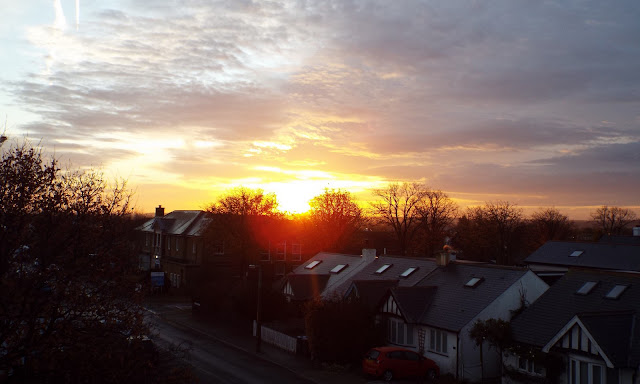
xmin=136 ymin=206 xmax=210 ymax=288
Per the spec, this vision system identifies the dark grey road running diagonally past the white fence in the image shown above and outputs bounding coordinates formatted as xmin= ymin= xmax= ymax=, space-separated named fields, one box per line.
xmin=149 ymin=308 xmax=313 ymax=384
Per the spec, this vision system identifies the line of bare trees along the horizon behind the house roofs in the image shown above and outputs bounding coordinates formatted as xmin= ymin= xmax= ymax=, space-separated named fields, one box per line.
xmin=208 ymin=183 xmax=636 ymax=265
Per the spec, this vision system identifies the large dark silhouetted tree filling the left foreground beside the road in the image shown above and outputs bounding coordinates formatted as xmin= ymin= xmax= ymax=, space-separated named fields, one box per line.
xmin=0 ymin=141 xmax=192 ymax=383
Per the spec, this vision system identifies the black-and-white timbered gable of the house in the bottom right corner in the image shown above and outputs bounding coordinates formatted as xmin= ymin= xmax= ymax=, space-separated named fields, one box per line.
xmin=542 ymin=315 xmax=614 ymax=368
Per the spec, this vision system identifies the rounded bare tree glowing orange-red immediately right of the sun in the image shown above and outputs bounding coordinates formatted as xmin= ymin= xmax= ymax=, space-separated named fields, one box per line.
xmin=309 ymin=189 xmax=364 ymax=251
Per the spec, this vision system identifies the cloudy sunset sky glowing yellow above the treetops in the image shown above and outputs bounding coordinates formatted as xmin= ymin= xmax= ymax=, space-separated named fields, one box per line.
xmin=0 ymin=0 xmax=640 ymax=219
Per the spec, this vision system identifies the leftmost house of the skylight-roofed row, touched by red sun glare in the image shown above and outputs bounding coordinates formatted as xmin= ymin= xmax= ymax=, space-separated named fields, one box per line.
xmin=283 ymin=249 xmax=376 ymax=302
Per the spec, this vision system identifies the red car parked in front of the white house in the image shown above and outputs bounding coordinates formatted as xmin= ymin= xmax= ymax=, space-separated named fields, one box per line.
xmin=362 ymin=347 xmax=440 ymax=381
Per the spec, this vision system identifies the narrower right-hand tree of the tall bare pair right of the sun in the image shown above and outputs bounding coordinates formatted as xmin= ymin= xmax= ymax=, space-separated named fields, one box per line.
xmin=418 ymin=190 xmax=458 ymax=256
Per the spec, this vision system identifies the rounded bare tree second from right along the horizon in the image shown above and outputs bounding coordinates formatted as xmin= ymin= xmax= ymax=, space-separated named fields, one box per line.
xmin=531 ymin=208 xmax=574 ymax=248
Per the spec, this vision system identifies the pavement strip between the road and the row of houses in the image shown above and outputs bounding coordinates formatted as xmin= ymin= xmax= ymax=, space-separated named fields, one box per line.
xmin=145 ymin=295 xmax=376 ymax=384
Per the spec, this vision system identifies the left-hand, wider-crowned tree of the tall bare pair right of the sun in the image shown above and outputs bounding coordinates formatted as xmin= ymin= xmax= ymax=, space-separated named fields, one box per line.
xmin=371 ymin=183 xmax=427 ymax=255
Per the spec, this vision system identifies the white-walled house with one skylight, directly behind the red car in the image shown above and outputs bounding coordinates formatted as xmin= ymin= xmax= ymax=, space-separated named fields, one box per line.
xmin=377 ymin=262 xmax=548 ymax=381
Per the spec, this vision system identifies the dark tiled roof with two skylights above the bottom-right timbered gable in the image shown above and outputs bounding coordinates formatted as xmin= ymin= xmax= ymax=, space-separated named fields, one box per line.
xmin=512 ymin=270 xmax=640 ymax=366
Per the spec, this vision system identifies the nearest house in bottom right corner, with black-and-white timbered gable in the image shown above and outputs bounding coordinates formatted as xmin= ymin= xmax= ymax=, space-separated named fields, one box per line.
xmin=503 ymin=269 xmax=640 ymax=384
